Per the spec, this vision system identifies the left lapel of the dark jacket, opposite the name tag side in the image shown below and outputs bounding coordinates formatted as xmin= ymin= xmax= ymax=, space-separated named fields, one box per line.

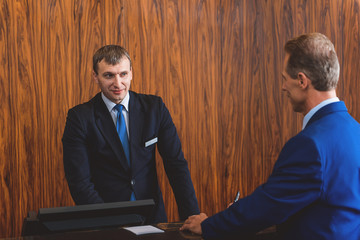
xmin=94 ymin=93 xmax=129 ymax=170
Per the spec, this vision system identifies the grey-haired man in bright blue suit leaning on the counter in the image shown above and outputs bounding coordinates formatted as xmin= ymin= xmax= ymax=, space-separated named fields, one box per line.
xmin=181 ymin=33 xmax=360 ymax=240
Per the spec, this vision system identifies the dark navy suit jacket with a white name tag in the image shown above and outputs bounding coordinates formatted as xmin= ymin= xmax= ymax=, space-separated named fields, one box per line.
xmin=62 ymin=92 xmax=199 ymax=222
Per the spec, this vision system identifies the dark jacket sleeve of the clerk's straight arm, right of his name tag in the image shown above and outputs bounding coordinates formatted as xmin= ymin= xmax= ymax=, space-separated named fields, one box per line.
xmin=158 ymin=101 xmax=199 ymax=220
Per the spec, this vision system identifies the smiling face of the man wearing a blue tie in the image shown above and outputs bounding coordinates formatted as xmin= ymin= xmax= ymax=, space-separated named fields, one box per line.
xmin=93 ymin=57 xmax=132 ymax=104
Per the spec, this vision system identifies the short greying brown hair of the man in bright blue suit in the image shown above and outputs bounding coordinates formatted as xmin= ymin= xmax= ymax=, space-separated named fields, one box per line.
xmin=285 ymin=33 xmax=340 ymax=91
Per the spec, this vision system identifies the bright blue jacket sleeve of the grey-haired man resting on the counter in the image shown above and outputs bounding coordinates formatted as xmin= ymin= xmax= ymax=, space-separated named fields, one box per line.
xmin=201 ymin=135 xmax=323 ymax=238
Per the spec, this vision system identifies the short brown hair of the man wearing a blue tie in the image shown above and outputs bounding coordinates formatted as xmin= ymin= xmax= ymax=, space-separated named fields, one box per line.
xmin=93 ymin=45 xmax=131 ymax=74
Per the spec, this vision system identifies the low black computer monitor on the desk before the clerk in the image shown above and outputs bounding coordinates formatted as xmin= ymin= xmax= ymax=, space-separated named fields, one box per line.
xmin=22 ymin=199 xmax=155 ymax=236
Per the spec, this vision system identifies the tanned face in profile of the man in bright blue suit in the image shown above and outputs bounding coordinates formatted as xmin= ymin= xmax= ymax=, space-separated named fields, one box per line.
xmin=282 ymin=54 xmax=306 ymax=113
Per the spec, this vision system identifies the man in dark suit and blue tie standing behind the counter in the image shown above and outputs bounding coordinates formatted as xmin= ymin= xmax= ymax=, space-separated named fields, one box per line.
xmin=62 ymin=45 xmax=199 ymax=223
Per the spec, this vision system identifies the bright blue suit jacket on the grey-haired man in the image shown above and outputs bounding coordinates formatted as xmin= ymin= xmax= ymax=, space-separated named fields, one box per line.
xmin=201 ymin=102 xmax=360 ymax=240
